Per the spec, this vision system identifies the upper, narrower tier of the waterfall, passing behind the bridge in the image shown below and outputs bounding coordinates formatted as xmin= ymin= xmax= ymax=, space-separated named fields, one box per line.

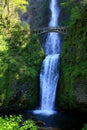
xmin=44 ymin=0 xmax=60 ymax=55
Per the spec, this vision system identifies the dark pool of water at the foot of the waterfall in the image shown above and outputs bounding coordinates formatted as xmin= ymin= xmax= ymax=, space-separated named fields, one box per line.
xmin=22 ymin=110 xmax=87 ymax=130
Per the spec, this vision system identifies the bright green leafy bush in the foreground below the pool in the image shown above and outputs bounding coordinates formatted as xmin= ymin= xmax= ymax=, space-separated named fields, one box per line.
xmin=0 ymin=115 xmax=37 ymax=130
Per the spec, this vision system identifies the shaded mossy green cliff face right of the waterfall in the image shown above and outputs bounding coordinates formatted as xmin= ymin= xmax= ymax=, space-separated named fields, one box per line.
xmin=57 ymin=1 xmax=87 ymax=112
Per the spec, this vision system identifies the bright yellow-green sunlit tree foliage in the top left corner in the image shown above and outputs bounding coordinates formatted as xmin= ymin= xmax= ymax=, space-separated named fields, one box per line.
xmin=0 ymin=0 xmax=28 ymax=32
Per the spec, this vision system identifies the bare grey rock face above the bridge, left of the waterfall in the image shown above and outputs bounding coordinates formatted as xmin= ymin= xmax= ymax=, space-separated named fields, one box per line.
xmin=22 ymin=0 xmax=50 ymax=28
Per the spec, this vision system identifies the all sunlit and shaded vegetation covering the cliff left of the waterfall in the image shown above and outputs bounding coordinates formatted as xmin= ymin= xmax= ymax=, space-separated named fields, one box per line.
xmin=0 ymin=0 xmax=44 ymax=110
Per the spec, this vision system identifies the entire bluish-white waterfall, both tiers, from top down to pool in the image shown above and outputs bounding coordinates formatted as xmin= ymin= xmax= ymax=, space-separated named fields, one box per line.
xmin=33 ymin=0 xmax=60 ymax=115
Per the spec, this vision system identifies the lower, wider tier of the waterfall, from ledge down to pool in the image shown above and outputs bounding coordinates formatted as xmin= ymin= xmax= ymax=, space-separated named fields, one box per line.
xmin=40 ymin=54 xmax=59 ymax=114
